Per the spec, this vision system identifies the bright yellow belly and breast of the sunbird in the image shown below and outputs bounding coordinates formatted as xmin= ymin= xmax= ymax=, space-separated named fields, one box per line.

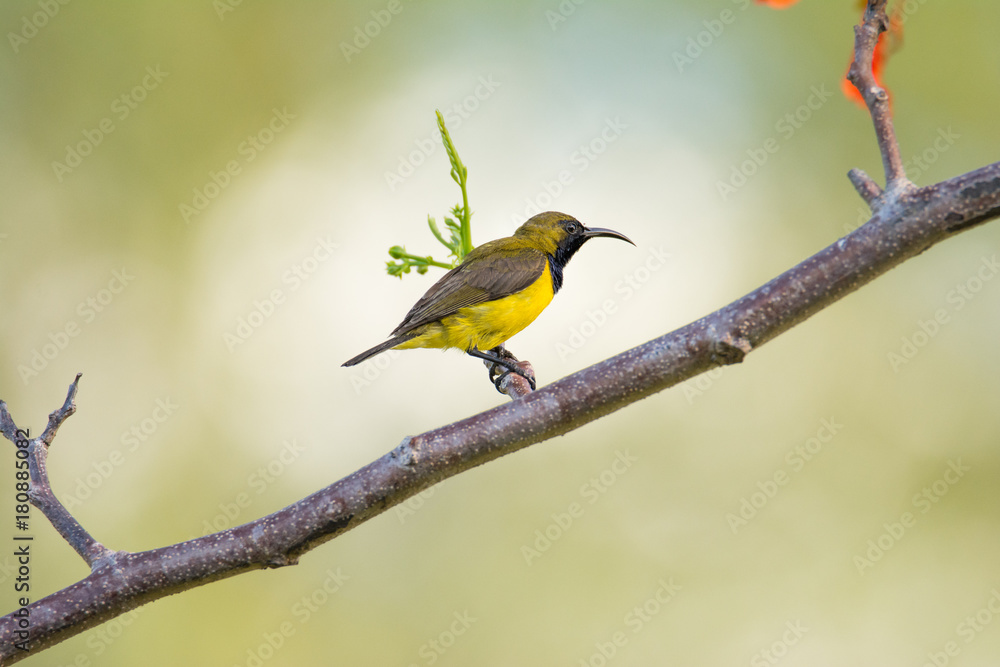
xmin=396 ymin=262 xmax=553 ymax=350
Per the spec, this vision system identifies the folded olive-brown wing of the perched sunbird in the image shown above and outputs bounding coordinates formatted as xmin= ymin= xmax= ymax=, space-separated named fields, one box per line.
xmin=392 ymin=245 xmax=546 ymax=336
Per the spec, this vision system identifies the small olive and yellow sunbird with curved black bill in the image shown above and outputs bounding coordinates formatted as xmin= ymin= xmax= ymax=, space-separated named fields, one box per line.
xmin=344 ymin=211 xmax=635 ymax=389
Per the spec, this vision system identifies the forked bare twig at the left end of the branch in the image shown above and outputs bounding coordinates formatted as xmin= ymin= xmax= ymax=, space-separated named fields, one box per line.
xmin=0 ymin=373 xmax=114 ymax=570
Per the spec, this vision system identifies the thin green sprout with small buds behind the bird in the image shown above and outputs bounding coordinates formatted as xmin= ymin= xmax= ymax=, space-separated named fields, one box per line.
xmin=386 ymin=111 xmax=472 ymax=279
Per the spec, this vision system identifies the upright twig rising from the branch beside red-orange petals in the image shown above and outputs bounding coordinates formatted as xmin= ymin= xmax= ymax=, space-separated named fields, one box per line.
xmin=847 ymin=0 xmax=913 ymax=196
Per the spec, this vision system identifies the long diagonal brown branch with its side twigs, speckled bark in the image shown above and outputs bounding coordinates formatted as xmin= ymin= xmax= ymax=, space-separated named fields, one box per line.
xmin=0 ymin=0 xmax=1000 ymax=664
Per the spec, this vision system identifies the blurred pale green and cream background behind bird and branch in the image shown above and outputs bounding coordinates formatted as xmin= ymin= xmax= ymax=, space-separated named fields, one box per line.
xmin=0 ymin=0 xmax=1000 ymax=667
